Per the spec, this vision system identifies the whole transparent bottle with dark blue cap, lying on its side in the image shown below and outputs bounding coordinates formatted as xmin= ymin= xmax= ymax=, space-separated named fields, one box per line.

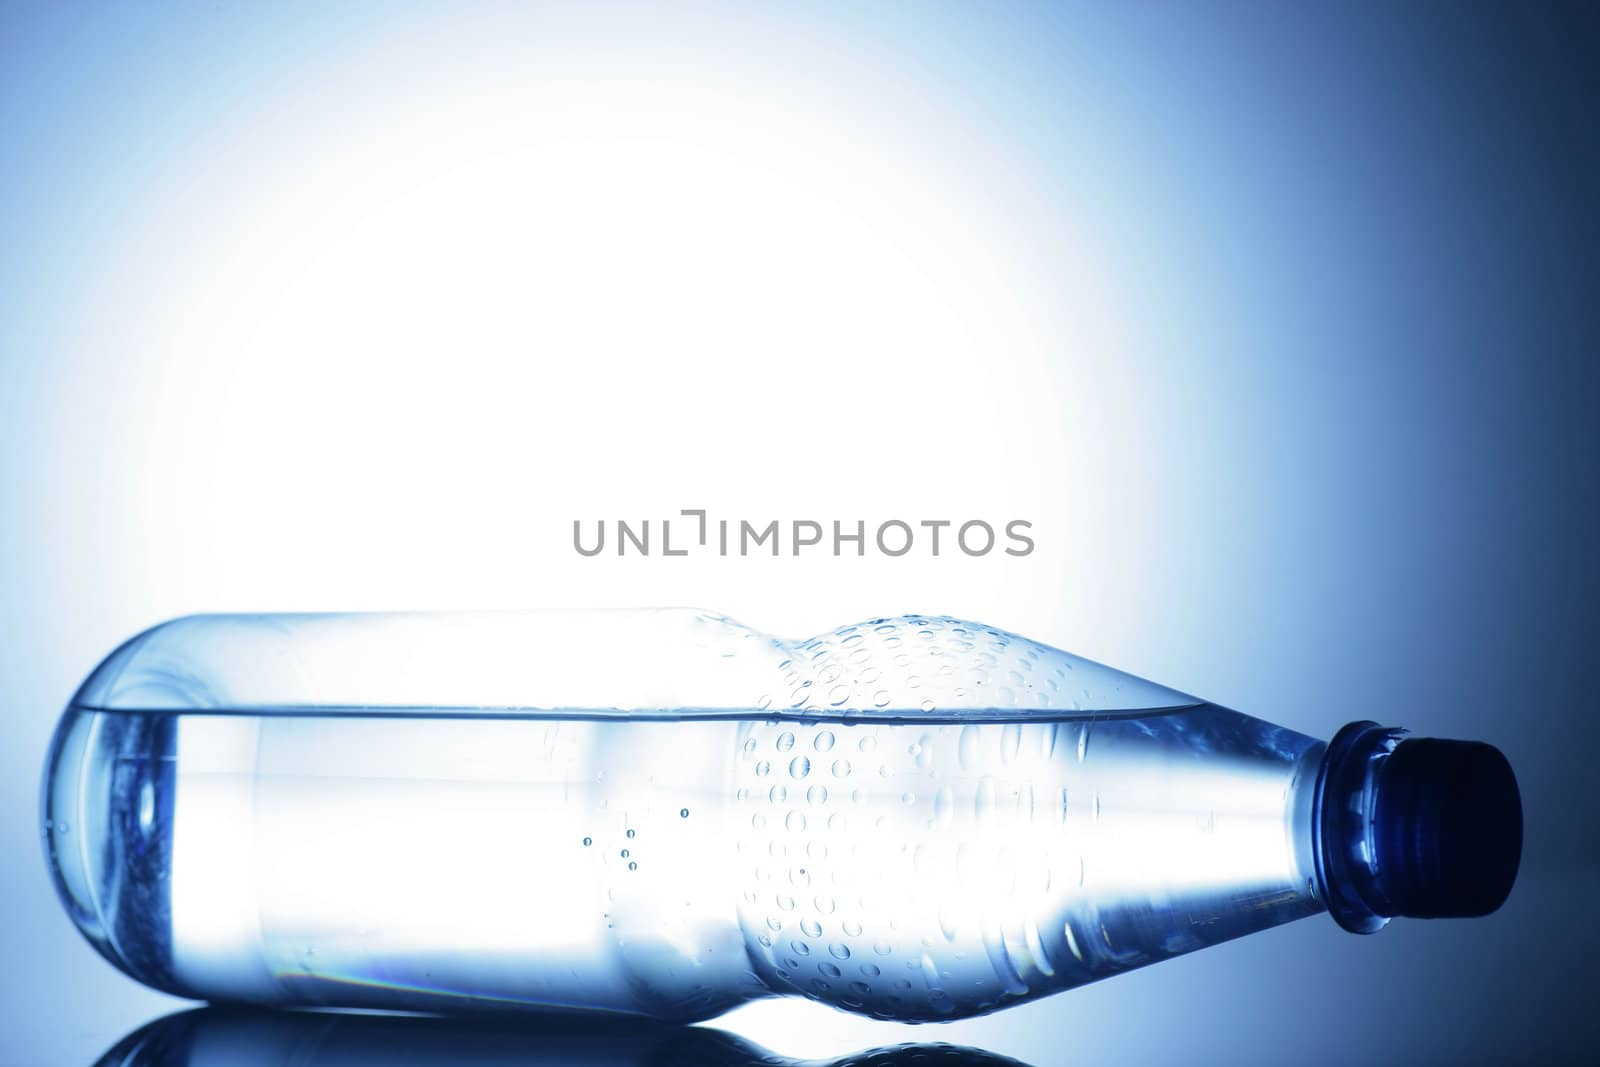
xmin=34 ymin=611 xmax=1522 ymax=1021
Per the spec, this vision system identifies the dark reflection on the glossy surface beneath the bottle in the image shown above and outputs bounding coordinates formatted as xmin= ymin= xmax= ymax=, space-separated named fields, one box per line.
xmin=96 ymin=1008 xmax=1026 ymax=1067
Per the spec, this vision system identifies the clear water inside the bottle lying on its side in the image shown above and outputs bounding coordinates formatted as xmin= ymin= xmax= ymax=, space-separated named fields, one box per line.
xmin=56 ymin=702 xmax=1320 ymax=1019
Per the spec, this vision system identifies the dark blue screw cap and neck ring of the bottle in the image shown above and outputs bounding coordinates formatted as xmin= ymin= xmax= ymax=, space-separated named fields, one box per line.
xmin=1310 ymin=721 xmax=1522 ymax=934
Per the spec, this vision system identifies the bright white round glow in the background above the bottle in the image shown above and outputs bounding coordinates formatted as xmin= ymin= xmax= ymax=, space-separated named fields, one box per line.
xmin=59 ymin=60 xmax=1126 ymax=653
